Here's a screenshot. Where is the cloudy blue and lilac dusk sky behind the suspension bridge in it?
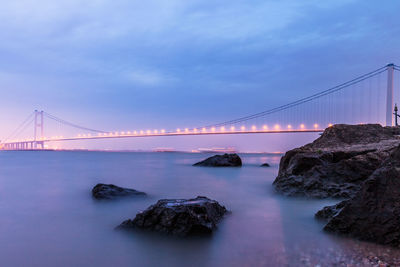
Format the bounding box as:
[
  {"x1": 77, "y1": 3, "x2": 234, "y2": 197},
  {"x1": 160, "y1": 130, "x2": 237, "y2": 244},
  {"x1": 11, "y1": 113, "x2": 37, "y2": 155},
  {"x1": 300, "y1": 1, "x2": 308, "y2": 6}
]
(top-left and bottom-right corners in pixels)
[{"x1": 0, "y1": 0, "x2": 400, "y2": 151}]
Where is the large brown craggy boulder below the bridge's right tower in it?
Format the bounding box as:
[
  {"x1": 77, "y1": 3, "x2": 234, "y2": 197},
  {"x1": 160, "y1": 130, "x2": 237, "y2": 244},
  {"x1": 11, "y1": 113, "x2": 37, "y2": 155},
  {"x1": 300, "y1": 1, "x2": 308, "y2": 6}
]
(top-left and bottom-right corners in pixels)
[{"x1": 273, "y1": 124, "x2": 400, "y2": 198}]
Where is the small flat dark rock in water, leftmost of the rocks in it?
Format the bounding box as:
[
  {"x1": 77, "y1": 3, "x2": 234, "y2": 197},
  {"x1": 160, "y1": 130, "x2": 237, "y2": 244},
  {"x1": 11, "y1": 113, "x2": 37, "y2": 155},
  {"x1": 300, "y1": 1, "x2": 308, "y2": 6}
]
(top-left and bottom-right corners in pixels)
[{"x1": 92, "y1": 184, "x2": 146, "y2": 199}]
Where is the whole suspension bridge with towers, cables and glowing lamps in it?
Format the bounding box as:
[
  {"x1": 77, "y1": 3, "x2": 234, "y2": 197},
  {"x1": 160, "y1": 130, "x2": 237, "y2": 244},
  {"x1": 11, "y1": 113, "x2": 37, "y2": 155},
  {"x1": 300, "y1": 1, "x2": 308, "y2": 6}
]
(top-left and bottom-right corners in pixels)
[{"x1": 0, "y1": 64, "x2": 400, "y2": 150}]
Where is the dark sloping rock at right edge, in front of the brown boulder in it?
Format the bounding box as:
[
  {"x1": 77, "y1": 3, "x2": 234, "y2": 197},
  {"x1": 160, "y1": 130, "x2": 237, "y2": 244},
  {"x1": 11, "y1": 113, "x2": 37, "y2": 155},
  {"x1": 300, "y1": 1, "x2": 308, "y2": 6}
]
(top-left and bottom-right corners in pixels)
[{"x1": 324, "y1": 147, "x2": 400, "y2": 247}]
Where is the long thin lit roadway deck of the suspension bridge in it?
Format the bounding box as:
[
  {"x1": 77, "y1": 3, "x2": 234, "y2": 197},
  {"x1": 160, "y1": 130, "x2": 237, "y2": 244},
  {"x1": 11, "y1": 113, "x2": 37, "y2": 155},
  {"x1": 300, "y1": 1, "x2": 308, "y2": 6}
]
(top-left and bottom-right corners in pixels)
[{"x1": 0, "y1": 129, "x2": 324, "y2": 150}]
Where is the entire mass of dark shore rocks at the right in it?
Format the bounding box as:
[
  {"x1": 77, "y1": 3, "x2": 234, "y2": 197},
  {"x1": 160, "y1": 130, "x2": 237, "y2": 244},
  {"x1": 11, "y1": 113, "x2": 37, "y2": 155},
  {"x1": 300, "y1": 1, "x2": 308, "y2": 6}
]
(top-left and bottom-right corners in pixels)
[{"x1": 273, "y1": 124, "x2": 400, "y2": 247}]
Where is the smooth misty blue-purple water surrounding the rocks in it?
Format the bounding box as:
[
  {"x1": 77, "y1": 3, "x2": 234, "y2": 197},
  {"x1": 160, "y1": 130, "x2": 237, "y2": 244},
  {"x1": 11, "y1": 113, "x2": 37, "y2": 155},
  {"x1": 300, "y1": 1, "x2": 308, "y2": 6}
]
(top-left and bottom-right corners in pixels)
[{"x1": 0, "y1": 151, "x2": 398, "y2": 266}]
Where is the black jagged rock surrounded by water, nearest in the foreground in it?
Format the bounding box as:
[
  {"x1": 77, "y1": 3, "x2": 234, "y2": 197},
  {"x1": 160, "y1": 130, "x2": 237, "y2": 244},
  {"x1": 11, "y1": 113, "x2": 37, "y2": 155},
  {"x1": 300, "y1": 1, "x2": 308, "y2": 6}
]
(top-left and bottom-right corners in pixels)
[{"x1": 117, "y1": 196, "x2": 227, "y2": 236}]
